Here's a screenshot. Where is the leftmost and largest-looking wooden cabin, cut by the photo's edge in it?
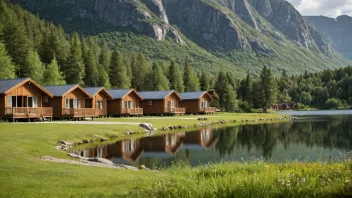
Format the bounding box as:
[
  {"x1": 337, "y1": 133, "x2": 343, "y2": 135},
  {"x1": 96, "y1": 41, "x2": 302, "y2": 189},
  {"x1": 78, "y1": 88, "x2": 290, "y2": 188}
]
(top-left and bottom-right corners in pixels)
[{"x1": 0, "y1": 78, "x2": 53, "y2": 121}]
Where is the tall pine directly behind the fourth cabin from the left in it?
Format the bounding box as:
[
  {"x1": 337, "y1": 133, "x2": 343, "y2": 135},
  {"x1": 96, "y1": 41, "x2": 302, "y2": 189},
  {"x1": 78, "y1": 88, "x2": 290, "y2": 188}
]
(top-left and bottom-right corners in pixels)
[{"x1": 110, "y1": 47, "x2": 130, "y2": 88}]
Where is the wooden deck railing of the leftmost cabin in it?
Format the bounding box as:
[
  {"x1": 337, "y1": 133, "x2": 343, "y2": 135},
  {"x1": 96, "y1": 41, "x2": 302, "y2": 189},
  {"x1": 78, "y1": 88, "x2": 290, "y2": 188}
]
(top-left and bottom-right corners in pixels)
[{"x1": 5, "y1": 107, "x2": 53, "y2": 117}]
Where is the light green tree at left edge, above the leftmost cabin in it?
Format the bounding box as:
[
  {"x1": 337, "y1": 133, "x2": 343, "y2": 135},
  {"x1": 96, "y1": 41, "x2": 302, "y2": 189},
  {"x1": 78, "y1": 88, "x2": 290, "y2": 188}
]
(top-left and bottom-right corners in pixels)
[{"x1": 0, "y1": 42, "x2": 16, "y2": 79}]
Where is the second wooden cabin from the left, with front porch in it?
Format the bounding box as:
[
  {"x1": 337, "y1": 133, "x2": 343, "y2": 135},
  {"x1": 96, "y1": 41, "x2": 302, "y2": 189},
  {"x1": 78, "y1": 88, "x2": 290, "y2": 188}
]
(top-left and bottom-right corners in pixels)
[{"x1": 44, "y1": 85, "x2": 96, "y2": 119}]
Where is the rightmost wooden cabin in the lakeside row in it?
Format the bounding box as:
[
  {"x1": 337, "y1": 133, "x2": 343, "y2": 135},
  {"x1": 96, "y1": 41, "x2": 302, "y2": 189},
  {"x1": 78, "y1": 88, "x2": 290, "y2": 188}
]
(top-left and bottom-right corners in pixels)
[{"x1": 180, "y1": 91, "x2": 216, "y2": 114}]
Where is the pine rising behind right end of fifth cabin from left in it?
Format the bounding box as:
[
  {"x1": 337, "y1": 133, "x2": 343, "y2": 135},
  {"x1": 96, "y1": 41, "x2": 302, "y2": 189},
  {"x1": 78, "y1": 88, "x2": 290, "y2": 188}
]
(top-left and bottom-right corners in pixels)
[{"x1": 168, "y1": 61, "x2": 184, "y2": 93}]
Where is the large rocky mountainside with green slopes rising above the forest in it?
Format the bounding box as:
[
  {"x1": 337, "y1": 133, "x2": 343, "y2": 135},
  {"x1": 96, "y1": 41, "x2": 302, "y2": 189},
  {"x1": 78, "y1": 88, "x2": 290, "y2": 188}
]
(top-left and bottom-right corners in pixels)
[{"x1": 11, "y1": 0, "x2": 351, "y2": 76}]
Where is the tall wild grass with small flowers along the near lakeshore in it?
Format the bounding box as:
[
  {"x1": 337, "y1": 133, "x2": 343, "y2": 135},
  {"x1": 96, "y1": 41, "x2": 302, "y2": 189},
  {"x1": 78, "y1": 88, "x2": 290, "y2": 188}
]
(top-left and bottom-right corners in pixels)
[{"x1": 131, "y1": 162, "x2": 352, "y2": 198}]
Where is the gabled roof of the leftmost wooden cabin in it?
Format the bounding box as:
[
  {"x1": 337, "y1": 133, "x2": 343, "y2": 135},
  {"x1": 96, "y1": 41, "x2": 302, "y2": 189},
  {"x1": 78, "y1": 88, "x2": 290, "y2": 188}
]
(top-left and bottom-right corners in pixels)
[{"x1": 0, "y1": 78, "x2": 53, "y2": 97}]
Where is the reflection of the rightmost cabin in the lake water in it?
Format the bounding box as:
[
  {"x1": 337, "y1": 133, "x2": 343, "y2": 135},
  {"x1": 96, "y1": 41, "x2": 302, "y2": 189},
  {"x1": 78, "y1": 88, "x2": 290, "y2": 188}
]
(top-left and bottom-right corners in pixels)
[{"x1": 182, "y1": 128, "x2": 219, "y2": 150}]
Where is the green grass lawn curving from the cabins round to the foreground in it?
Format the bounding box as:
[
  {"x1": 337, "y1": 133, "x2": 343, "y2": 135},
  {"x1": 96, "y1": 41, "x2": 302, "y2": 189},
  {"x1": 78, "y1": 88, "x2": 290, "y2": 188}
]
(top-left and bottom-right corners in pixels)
[{"x1": 0, "y1": 114, "x2": 352, "y2": 197}]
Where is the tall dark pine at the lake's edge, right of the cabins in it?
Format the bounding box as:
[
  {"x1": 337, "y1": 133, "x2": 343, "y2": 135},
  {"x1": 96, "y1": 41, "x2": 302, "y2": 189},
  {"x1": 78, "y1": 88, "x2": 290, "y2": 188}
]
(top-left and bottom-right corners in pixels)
[{"x1": 260, "y1": 66, "x2": 276, "y2": 113}]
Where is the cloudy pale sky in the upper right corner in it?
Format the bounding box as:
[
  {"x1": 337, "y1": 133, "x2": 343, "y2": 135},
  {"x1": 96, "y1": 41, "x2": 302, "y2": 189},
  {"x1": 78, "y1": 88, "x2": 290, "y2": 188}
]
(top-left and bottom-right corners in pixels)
[{"x1": 287, "y1": 0, "x2": 352, "y2": 18}]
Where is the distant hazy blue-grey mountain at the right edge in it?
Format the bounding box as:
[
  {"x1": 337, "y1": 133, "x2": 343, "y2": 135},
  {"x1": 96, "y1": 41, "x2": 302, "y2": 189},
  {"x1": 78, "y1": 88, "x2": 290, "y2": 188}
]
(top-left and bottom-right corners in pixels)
[{"x1": 304, "y1": 15, "x2": 352, "y2": 59}]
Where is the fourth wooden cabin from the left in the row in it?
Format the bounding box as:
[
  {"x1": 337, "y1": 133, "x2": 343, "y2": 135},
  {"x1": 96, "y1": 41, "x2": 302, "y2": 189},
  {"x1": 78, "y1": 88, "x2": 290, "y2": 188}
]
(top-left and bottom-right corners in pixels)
[{"x1": 108, "y1": 89, "x2": 143, "y2": 116}]
